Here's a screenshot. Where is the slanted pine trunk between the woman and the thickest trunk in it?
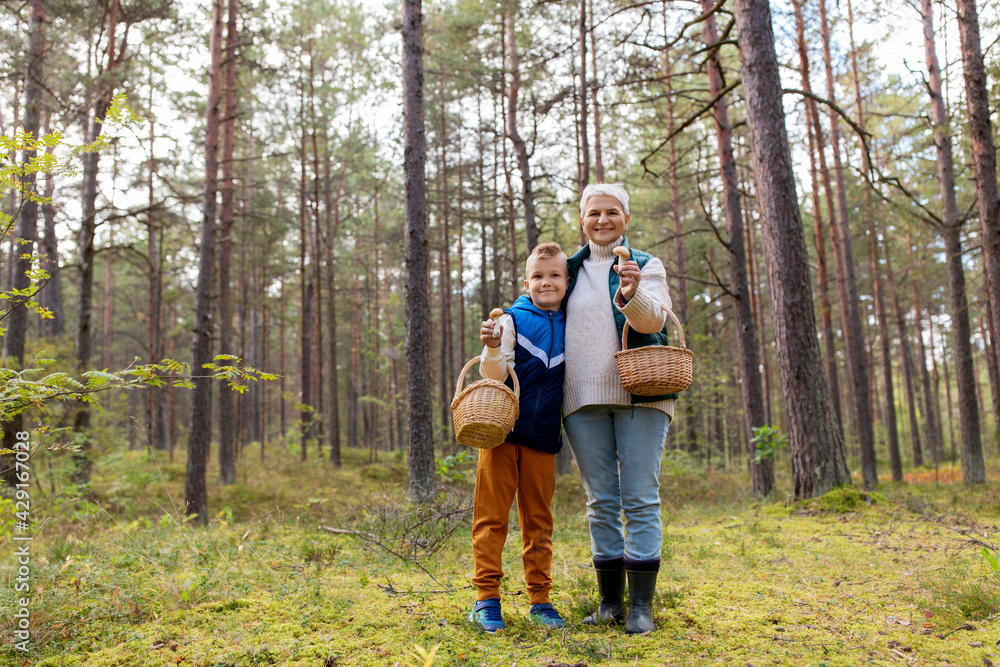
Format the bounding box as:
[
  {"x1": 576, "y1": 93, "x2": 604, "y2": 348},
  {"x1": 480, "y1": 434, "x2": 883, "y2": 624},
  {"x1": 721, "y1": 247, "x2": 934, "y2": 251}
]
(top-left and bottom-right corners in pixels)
[{"x1": 701, "y1": 0, "x2": 774, "y2": 497}]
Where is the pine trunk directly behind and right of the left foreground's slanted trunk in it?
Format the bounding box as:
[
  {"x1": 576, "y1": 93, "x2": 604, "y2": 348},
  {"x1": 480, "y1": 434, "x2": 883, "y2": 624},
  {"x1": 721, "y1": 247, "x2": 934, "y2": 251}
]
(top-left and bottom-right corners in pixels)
[{"x1": 219, "y1": 0, "x2": 237, "y2": 486}]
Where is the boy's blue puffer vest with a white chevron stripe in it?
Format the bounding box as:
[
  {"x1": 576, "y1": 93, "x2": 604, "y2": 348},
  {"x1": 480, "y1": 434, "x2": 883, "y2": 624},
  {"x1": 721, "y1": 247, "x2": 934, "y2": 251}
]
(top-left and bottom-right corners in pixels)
[{"x1": 504, "y1": 296, "x2": 566, "y2": 454}]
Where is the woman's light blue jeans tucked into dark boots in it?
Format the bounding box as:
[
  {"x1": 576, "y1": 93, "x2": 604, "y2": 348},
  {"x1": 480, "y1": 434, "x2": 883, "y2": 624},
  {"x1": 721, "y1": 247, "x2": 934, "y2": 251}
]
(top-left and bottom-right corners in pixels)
[{"x1": 563, "y1": 405, "x2": 669, "y2": 561}]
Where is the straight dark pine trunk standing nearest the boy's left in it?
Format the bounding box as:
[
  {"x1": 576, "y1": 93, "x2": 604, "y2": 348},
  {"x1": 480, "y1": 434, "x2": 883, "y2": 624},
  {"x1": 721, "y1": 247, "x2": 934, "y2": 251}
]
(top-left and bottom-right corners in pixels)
[{"x1": 403, "y1": 0, "x2": 436, "y2": 501}]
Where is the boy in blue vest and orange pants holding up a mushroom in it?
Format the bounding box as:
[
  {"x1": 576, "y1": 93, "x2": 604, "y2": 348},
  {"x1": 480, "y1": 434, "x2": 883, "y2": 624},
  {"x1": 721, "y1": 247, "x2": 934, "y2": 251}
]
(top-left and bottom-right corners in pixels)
[{"x1": 470, "y1": 243, "x2": 569, "y2": 632}]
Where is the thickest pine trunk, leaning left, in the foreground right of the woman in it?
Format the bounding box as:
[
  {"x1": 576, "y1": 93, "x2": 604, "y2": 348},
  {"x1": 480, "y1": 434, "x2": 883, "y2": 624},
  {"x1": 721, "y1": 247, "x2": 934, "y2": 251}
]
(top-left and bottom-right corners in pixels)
[{"x1": 734, "y1": 0, "x2": 851, "y2": 498}]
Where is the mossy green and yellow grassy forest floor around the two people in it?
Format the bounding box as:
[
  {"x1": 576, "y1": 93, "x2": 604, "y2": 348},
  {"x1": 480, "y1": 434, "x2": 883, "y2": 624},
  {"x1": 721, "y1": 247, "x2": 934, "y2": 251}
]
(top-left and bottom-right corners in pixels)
[{"x1": 0, "y1": 449, "x2": 1000, "y2": 667}]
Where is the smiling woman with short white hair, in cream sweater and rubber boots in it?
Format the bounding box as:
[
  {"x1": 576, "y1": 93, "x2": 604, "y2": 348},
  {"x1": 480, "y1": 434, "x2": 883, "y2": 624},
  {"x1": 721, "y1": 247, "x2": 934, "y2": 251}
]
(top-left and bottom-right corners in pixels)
[{"x1": 563, "y1": 183, "x2": 676, "y2": 634}]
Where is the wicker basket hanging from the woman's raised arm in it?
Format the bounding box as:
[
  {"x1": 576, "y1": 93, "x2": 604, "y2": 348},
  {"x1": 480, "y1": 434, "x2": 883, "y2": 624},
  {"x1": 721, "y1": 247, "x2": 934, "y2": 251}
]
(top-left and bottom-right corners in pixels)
[{"x1": 615, "y1": 304, "x2": 694, "y2": 396}]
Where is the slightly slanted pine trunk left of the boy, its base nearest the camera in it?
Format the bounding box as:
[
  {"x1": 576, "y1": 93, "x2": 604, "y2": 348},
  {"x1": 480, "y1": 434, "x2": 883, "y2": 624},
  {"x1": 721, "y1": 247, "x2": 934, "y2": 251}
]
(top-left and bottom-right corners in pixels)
[{"x1": 184, "y1": 0, "x2": 224, "y2": 525}]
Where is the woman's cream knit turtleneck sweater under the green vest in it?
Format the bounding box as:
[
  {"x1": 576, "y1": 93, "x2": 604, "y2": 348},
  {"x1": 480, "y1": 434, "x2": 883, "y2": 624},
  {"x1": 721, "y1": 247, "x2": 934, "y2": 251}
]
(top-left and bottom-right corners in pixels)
[{"x1": 563, "y1": 238, "x2": 674, "y2": 421}]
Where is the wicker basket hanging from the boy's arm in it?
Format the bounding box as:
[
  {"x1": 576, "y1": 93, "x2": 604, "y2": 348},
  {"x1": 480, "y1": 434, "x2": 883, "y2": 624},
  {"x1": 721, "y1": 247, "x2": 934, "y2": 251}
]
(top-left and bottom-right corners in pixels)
[{"x1": 451, "y1": 357, "x2": 521, "y2": 449}]
